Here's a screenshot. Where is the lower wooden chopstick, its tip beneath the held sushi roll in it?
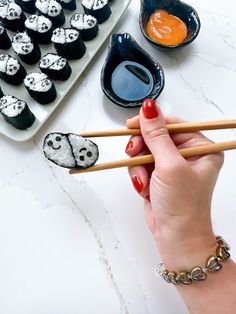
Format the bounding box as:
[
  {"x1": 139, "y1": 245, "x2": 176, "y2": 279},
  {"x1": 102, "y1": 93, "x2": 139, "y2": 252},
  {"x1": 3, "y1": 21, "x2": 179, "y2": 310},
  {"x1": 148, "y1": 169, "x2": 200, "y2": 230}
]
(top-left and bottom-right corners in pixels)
[{"x1": 69, "y1": 141, "x2": 236, "y2": 174}]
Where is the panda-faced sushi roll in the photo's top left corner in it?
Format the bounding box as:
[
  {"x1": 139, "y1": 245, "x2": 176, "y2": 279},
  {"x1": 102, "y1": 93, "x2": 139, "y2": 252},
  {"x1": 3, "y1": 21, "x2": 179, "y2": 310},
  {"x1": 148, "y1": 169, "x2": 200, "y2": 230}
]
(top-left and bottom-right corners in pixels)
[{"x1": 0, "y1": 0, "x2": 25, "y2": 32}]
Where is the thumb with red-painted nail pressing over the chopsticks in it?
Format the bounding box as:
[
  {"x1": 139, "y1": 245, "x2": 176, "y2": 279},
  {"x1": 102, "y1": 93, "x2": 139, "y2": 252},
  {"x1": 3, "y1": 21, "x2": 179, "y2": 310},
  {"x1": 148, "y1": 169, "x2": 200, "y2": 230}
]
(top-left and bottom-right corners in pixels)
[{"x1": 140, "y1": 99, "x2": 183, "y2": 165}]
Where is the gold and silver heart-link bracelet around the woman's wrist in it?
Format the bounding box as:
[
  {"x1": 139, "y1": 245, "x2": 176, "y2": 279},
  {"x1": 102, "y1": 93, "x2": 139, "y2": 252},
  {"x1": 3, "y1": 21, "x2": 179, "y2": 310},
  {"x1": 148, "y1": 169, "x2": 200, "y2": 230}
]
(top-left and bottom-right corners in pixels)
[{"x1": 156, "y1": 236, "x2": 230, "y2": 285}]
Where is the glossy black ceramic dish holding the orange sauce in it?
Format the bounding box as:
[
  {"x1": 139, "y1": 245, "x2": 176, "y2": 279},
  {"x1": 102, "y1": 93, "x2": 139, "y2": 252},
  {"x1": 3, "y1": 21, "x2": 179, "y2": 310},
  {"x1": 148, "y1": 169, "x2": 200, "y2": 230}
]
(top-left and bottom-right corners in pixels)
[{"x1": 139, "y1": 0, "x2": 201, "y2": 51}]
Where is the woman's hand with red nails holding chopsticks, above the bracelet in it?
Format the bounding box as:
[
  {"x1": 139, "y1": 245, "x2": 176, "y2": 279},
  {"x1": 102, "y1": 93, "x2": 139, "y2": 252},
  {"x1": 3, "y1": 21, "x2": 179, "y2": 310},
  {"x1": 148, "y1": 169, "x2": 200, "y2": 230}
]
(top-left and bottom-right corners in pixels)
[{"x1": 126, "y1": 100, "x2": 223, "y2": 269}]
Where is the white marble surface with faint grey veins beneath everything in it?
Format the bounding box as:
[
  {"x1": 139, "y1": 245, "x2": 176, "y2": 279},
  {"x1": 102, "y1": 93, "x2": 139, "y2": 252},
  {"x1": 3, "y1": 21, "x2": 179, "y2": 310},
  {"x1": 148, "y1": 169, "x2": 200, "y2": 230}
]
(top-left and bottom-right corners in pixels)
[{"x1": 0, "y1": 0, "x2": 236, "y2": 314}]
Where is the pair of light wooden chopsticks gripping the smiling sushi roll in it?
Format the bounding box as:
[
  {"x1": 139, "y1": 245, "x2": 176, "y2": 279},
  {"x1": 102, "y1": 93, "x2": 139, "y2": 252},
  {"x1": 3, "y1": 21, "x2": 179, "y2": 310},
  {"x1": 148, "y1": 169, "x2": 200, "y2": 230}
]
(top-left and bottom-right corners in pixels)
[{"x1": 69, "y1": 119, "x2": 236, "y2": 174}]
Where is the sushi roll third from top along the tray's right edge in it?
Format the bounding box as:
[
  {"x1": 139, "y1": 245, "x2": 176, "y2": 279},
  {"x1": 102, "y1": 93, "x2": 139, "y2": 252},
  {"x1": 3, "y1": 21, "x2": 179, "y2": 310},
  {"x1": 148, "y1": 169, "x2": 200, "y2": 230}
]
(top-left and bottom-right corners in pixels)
[{"x1": 52, "y1": 28, "x2": 86, "y2": 60}]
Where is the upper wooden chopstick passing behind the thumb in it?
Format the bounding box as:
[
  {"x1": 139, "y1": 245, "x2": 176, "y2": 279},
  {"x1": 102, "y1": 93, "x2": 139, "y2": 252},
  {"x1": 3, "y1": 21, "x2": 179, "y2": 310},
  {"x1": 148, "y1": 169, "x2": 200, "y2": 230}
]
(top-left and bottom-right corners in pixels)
[{"x1": 79, "y1": 119, "x2": 236, "y2": 137}]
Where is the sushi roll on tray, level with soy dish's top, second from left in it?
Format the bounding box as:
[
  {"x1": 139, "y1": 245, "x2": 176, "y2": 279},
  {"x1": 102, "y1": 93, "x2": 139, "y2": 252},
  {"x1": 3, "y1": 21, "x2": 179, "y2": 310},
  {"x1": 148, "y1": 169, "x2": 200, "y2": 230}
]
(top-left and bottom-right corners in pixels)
[{"x1": 12, "y1": 32, "x2": 41, "y2": 64}]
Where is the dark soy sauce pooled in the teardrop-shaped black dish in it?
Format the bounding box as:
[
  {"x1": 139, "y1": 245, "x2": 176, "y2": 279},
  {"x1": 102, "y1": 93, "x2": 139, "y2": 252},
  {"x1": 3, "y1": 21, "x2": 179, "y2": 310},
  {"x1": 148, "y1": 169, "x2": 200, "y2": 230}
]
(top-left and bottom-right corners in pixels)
[{"x1": 111, "y1": 61, "x2": 154, "y2": 101}]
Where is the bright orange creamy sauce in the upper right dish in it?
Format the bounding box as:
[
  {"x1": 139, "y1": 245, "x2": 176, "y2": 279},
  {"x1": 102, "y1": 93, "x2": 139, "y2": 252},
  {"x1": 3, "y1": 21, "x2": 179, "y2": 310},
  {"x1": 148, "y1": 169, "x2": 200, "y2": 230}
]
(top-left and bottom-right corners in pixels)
[{"x1": 146, "y1": 10, "x2": 187, "y2": 45}]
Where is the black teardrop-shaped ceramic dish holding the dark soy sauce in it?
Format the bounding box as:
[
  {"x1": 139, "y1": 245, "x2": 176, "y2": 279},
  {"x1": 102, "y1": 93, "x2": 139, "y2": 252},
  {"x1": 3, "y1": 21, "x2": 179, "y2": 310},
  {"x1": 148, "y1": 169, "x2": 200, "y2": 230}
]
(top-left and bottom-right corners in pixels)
[{"x1": 101, "y1": 33, "x2": 165, "y2": 108}]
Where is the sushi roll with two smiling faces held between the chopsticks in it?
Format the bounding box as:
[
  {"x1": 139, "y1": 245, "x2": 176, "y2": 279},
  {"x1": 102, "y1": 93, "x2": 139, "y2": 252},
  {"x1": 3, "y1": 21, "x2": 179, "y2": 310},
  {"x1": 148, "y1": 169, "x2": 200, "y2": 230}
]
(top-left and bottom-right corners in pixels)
[{"x1": 43, "y1": 133, "x2": 99, "y2": 168}]
